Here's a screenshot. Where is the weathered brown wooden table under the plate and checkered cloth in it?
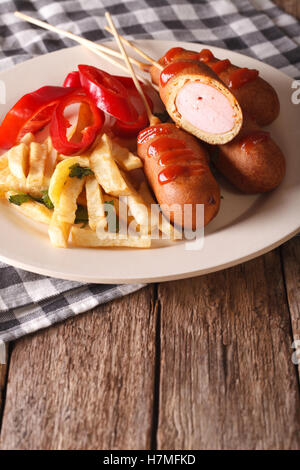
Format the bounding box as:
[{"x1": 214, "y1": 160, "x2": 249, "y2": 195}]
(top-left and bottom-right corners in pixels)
[{"x1": 0, "y1": 0, "x2": 300, "y2": 449}]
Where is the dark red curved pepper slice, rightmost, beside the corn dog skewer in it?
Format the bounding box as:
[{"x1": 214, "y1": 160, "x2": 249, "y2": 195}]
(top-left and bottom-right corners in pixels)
[{"x1": 112, "y1": 77, "x2": 153, "y2": 137}]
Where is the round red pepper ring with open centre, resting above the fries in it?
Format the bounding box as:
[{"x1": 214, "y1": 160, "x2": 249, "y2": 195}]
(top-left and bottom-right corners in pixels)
[{"x1": 50, "y1": 91, "x2": 104, "y2": 155}]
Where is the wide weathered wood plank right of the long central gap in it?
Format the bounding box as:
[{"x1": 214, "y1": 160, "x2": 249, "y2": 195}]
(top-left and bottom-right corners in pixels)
[{"x1": 158, "y1": 251, "x2": 300, "y2": 449}]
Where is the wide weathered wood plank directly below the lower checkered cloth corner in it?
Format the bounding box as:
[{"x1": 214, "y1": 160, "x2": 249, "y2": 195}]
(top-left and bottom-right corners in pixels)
[{"x1": 0, "y1": 287, "x2": 156, "y2": 449}]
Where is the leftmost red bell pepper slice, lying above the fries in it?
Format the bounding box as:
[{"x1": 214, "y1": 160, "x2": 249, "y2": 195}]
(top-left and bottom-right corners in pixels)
[{"x1": 0, "y1": 86, "x2": 73, "y2": 149}]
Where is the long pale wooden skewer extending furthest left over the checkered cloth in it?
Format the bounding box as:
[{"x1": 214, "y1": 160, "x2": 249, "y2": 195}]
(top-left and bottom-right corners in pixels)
[{"x1": 15, "y1": 11, "x2": 147, "y2": 71}]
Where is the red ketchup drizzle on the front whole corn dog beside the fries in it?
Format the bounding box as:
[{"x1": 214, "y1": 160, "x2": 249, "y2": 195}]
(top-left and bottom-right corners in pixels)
[{"x1": 147, "y1": 136, "x2": 205, "y2": 184}]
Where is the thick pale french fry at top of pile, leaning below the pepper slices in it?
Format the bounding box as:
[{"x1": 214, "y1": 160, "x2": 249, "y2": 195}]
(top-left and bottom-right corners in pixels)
[{"x1": 90, "y1": 134, "x2": 129, "y2": 196}]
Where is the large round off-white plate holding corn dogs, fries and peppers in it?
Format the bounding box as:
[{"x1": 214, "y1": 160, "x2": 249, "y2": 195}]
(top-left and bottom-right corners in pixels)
[{"x1": 0, "y1": 41, "x2": 300, "y2": 283}]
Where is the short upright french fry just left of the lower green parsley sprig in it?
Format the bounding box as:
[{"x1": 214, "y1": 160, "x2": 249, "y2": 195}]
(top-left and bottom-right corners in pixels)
[{"x1": 55, "y1": 177, "x2": 85, "y2": 224}]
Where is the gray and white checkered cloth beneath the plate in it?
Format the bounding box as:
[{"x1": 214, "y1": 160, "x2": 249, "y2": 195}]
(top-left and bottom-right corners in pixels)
[{"x1": 0, "y1": 0, "x2": 300, "y2": 342}]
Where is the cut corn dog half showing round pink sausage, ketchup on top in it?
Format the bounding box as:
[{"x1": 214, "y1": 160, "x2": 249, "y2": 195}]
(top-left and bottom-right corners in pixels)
[{"x1": 159, "y1": 60, "x2": 243, "y2": 144}]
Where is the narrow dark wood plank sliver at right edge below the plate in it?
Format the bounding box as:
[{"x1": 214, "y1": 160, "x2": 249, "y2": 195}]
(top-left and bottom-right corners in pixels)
[{"x1": 281, "y1": 237, "x2": 300, "y2": 376}]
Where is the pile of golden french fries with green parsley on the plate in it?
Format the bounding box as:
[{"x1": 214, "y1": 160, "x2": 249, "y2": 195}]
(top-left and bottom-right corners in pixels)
[{"x1": 0, "y1": 106, "x2": 181, "y2": 248}]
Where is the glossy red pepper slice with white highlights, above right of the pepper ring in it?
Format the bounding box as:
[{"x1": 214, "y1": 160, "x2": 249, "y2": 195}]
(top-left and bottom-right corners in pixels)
[{"x1": 78, "y1": 65, "x2": 138, "y2": 122}]
